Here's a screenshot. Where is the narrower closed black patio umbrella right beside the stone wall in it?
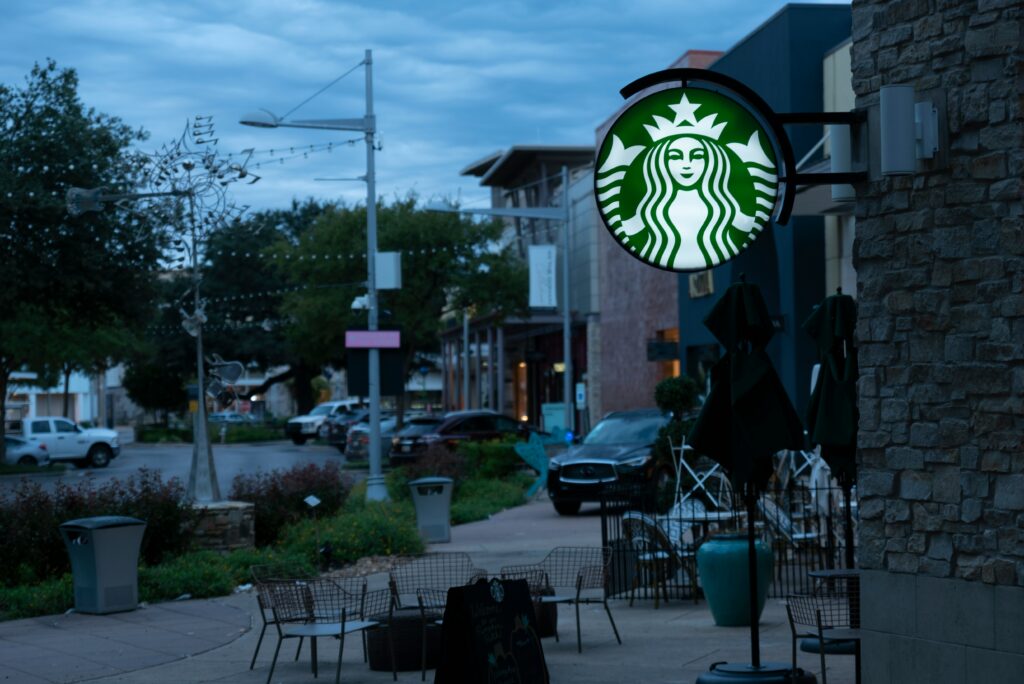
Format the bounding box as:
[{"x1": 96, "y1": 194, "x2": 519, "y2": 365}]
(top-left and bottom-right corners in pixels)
[{"x1": 804, "y1": 289, "x2": 860, "y2": 567}]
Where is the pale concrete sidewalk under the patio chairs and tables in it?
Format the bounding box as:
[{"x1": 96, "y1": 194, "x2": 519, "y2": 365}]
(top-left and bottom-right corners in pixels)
[{"x1": 0, "y1": 501, "x2": 853, "y2": 684}]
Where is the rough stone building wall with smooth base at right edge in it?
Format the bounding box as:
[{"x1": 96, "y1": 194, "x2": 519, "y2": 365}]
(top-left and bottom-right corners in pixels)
[{"x1": 852, "y1": 0, "x2": 1024, "y2": 684}]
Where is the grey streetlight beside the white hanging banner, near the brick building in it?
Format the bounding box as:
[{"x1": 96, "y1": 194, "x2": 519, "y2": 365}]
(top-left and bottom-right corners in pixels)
[{"x1": 426, "y1": 166, "x2": 575, "y2": 431}]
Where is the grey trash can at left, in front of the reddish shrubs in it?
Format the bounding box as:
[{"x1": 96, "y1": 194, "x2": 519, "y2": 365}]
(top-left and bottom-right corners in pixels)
[{"x1": 60, "y1": 515, "x2": 145, "y2": 613}]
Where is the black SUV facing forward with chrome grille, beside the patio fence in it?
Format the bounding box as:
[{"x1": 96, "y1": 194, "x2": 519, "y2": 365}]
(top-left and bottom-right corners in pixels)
[{"x1": 548, "y1": 409, "x2": 675, "y2": 515}]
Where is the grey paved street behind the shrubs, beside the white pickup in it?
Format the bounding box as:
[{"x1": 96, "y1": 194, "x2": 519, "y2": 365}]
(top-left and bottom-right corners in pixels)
[{"x1": 0, "y1": 440, "x2": 359, "y2": 496}]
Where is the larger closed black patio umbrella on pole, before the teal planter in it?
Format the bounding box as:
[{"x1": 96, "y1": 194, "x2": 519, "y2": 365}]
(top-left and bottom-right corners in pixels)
[{"x1": 689, "y1": 275, "x2": 804, "y2": 681}]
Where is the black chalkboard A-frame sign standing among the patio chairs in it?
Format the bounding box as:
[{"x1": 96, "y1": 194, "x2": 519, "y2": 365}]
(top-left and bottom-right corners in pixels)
[{"x1": 434, "y1": 580, "x2": 550, "y2": 684}]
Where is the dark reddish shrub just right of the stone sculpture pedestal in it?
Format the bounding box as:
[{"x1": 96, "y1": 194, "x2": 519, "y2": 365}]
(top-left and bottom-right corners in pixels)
[{"x1": 229, "y1": 463, "x2": 351, "y2": 546}]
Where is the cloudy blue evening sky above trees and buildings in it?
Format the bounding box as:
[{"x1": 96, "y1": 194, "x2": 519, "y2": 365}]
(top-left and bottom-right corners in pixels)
[{"x1": 0, "y1": 0, "x2": 847, "y2": 214}]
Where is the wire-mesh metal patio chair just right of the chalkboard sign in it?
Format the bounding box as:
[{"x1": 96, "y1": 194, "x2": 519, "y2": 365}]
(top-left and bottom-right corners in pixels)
[{"x1": 502, "y1": 546, "x2": 623, "y2": 653}]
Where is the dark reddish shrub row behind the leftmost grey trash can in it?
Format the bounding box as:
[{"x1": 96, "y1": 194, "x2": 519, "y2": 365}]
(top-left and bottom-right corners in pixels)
[{"x1": 0, "y1": 468, "x2": 198, "y2": 586}]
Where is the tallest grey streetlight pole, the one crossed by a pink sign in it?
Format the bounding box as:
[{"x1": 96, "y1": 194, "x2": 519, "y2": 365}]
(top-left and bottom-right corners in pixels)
[{"x1": 239, "y1": 50, "x2": 388, "y2": 501}]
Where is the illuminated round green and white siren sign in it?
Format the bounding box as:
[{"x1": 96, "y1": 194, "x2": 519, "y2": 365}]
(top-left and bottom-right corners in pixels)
[{"x1": 594, "y1": 88, "x2": 778, "y2": 271}]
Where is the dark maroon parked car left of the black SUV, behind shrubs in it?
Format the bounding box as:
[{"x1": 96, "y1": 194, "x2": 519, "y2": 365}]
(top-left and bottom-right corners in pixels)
[{"x1": 390, "y1": 411, "x2": 532, "y2": 463}]
